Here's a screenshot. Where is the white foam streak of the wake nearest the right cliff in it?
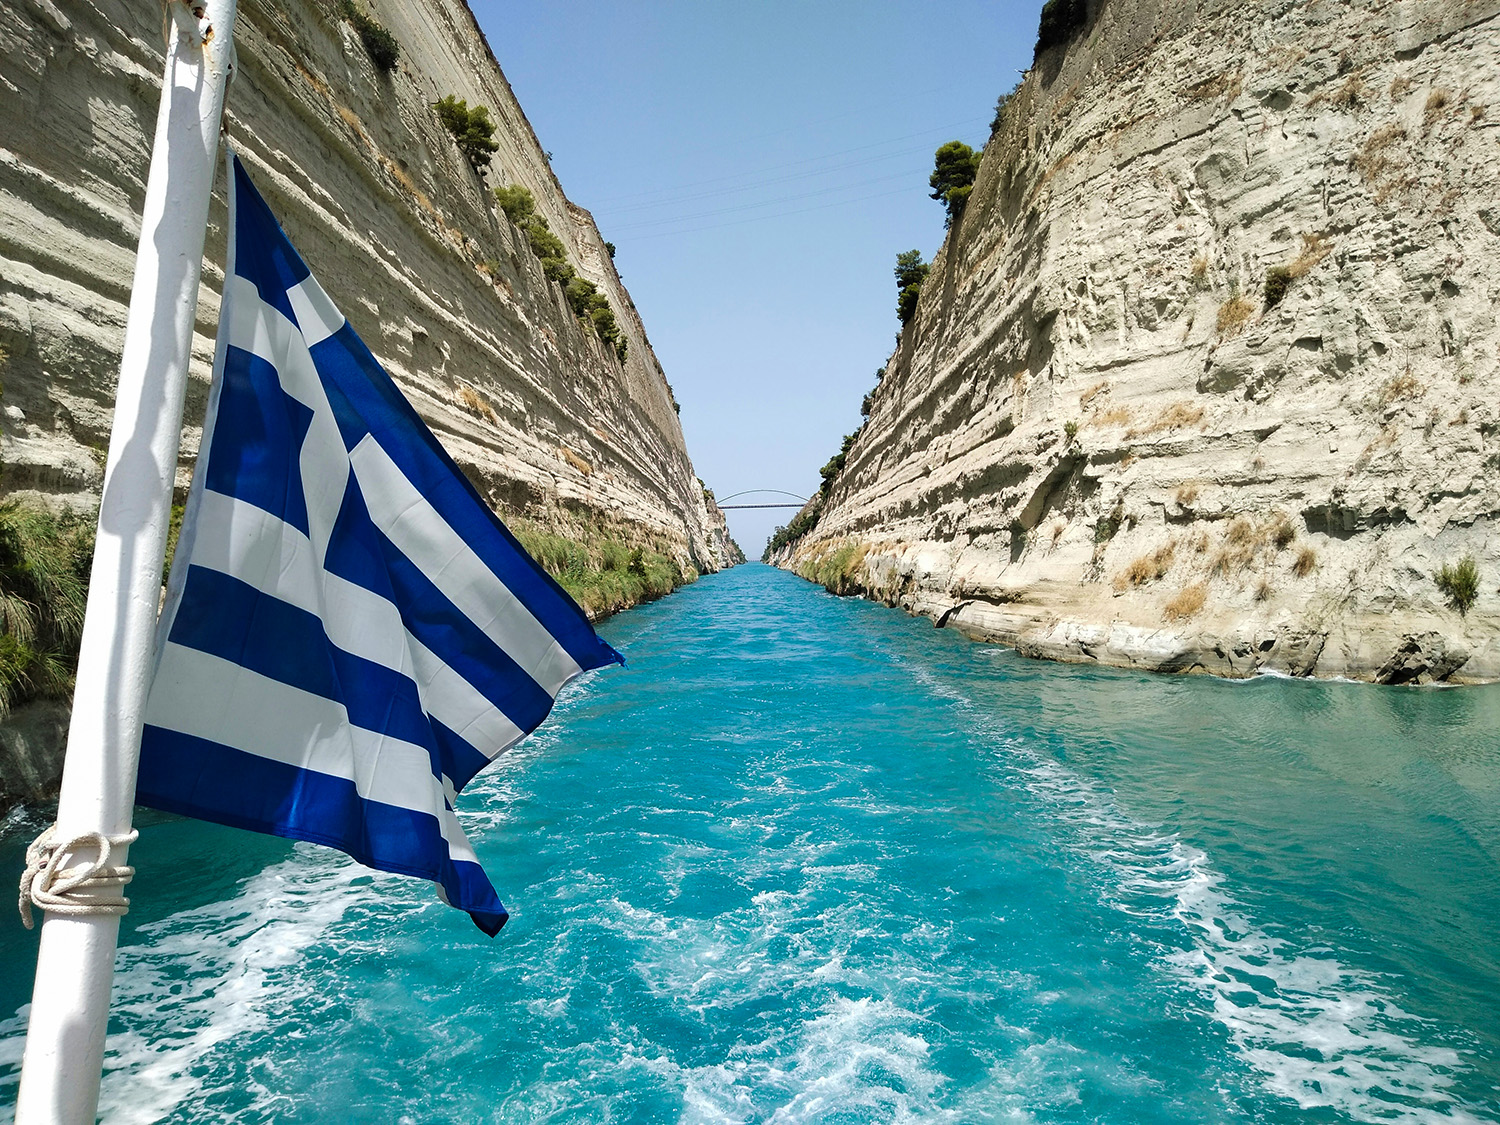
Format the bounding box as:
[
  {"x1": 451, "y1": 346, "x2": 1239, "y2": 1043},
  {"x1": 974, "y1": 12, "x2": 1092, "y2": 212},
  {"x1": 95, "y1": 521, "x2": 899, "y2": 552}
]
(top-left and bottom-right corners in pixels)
[{"x1": 909, "y1": 666, "x2": 1490, "y2": 1125}]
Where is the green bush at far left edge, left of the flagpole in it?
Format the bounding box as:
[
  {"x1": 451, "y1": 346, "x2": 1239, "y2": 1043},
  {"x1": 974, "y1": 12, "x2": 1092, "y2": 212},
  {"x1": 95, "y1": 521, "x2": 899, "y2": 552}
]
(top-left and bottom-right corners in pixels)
[{"x1": 0, "y1": 500, "x2": 95, "y2": 716}]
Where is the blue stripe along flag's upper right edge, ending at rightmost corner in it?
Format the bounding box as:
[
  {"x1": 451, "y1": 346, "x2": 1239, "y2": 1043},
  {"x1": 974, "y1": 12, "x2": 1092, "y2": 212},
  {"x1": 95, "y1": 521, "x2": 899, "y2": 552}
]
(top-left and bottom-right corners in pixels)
[{"x1": 312, "y1": 324, "x2": 624, "y2": 671}]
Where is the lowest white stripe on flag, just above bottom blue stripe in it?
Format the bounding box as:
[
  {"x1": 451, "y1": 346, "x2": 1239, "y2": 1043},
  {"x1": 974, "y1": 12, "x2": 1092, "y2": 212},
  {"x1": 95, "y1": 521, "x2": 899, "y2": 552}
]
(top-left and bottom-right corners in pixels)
[{"x1": 146, "y1": 642, "x2": 476, "y2": 863}]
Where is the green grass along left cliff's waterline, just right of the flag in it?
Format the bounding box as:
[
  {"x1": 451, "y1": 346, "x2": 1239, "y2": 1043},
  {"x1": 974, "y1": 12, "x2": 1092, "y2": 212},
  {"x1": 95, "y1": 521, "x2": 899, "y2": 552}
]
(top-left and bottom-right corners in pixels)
[{"x1": 506, "y1": 518, "x2": 698, "y2": 620}]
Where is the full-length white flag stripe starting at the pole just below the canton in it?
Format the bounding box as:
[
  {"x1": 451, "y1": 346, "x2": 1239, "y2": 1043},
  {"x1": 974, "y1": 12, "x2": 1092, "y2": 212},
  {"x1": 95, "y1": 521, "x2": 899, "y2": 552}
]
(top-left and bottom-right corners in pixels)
[{"x1": 192, "y1": 491, "x2": 524, "y2": 758}]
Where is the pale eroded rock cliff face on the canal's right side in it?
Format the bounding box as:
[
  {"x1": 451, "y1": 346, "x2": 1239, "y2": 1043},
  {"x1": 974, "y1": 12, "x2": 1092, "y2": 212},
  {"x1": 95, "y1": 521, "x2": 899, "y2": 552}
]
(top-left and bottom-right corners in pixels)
[{"x1": 777, "y1": 0, "x2": 1500, "y2": 680}]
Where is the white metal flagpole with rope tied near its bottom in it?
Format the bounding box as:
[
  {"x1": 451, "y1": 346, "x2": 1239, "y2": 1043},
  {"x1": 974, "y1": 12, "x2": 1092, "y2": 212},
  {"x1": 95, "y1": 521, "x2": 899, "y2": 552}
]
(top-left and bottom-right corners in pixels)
[{"x1": 15, "y1": 0, "x2": 236, "y2": 1125}]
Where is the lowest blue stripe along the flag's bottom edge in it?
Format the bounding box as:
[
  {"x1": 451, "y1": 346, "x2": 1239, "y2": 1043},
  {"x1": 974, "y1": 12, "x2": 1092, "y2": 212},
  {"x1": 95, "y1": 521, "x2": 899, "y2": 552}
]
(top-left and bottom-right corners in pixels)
[{"x1": 137, "y1": 726, "x2": 509, "y2": 936}]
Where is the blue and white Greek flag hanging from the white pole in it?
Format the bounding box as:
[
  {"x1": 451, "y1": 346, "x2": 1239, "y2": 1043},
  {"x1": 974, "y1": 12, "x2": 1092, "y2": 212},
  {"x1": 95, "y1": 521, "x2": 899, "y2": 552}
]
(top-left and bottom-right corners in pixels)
[{"x1": 137, "y1": 155, "x2": 620, "y2": 935}]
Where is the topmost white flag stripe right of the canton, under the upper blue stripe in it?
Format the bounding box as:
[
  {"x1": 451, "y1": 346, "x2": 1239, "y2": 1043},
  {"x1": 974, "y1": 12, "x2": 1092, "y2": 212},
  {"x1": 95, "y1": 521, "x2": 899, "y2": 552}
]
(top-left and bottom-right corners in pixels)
[{"x1": 350, "y1": 434, "x2": 582, "y2": 696}]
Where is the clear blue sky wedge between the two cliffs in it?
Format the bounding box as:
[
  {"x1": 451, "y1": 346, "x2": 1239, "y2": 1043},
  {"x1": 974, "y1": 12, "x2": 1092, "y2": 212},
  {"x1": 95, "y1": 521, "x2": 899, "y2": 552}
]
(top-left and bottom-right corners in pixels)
[{"x1": 473, "y1": 0, "x2": 1041, "y2": 557}]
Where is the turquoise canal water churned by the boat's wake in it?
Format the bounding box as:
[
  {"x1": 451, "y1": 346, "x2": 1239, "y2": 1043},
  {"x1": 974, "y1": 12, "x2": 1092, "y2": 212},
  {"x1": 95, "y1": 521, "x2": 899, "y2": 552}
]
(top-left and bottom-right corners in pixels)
[{"x1": 0, "y1": 566, "x2": 1500, "y2": 1124}]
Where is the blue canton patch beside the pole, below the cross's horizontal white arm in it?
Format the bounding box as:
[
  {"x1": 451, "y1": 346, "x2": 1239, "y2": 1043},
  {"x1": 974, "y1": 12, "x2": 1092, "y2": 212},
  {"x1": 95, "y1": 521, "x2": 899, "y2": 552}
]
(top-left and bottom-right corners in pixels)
[{"x1": 204, "y1": 347, "x2": 312, "y2": 536}]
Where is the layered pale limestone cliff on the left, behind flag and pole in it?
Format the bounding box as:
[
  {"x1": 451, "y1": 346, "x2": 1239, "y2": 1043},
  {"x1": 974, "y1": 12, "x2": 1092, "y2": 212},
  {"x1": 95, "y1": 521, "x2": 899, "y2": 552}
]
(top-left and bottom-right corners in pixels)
[{"x1": 0, "y1": 0, "x2": 731, "y2": 810}]
